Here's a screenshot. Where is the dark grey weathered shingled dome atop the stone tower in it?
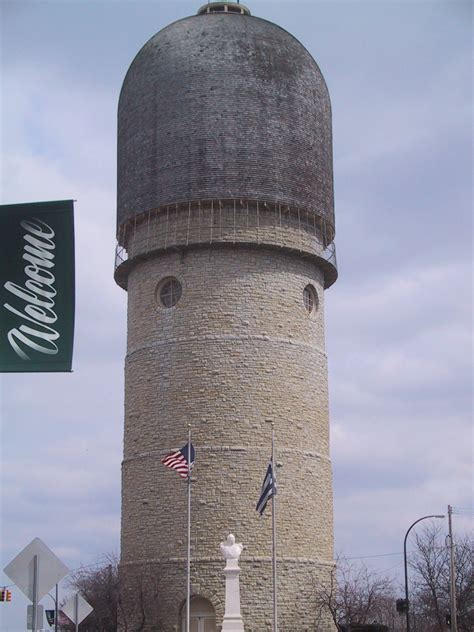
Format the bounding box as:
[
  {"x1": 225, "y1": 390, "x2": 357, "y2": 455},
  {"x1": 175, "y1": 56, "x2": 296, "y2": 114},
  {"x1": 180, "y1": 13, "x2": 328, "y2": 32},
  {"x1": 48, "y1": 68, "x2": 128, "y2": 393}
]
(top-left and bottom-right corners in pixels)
[{"x1": 118, "y1": 7, "x2": 334, "y2": 233}]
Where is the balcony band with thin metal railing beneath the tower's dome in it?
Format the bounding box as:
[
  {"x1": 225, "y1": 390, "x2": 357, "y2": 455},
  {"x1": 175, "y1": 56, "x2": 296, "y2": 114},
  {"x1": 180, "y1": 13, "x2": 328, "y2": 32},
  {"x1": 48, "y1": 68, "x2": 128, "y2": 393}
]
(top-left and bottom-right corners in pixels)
[{"x1": 115, "y1": 199, "x2": 337, "y2": 276}]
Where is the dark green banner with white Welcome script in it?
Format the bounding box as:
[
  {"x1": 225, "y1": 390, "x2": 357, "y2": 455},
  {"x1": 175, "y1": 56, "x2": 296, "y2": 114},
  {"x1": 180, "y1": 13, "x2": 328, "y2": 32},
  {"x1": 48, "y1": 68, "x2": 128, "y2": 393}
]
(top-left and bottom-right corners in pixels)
[{"x1": 0, "y1": 200, "x2": 75, "y2": 372}]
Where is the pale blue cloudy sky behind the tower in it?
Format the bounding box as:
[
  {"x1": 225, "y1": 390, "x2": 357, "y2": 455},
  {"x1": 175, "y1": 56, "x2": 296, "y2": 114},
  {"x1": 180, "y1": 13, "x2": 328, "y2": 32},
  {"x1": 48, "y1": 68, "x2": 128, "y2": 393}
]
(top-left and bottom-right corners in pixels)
[{"x1": 0, "y1": 0, "x2": 473, "y2": 632}]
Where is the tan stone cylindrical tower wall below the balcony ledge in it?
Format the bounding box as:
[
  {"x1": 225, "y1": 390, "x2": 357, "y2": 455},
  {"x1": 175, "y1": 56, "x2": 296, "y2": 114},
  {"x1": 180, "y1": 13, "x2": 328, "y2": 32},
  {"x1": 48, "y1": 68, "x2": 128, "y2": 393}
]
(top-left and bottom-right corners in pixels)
[{"x1": 121, "y1": 244, "x2": 333, "y2": 632}]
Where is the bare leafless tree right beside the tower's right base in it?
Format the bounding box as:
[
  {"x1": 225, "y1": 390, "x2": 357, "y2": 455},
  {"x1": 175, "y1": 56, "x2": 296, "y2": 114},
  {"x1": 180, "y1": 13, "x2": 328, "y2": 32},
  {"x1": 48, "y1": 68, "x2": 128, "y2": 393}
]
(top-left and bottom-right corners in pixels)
[{"x1": 316, "y1": 557, "x2": 395, "y2": 630}]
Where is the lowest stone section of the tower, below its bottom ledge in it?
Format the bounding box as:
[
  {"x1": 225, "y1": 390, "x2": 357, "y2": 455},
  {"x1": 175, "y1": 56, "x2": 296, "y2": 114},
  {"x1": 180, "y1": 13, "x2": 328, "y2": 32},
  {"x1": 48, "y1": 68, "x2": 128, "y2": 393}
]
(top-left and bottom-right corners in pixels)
[{"x1": 118, "y1": 557, "x2": 335, "y2": 632}]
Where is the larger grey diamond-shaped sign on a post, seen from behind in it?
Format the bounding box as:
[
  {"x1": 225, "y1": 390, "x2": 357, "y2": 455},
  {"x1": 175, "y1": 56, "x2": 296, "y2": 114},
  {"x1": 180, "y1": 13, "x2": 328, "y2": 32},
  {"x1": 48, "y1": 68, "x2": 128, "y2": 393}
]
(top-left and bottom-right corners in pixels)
[{"x1": 3, "y1": 538, "x2": 69, "y2": 632}]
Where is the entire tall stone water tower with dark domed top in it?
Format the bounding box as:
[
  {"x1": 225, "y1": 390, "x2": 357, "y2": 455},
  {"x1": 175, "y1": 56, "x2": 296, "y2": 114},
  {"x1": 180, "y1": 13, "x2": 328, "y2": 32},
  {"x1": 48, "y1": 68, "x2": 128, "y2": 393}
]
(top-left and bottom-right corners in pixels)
[{"x1": 115, "y1": 2, "x2": 337, "y2": 632}]
